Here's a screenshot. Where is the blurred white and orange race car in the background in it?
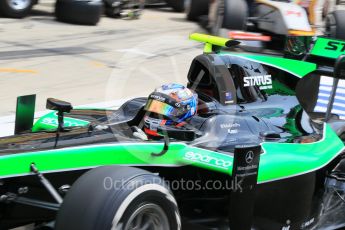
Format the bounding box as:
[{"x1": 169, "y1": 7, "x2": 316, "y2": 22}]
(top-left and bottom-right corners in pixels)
[{"x1": 187, "y1": 0, "x2": 345, "y2": 51}]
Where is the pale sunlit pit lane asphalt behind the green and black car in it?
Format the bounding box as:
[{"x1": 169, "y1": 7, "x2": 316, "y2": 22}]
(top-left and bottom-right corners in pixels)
[{"x1": 0, "y1": 2, "x2": 202, "y2": 120}]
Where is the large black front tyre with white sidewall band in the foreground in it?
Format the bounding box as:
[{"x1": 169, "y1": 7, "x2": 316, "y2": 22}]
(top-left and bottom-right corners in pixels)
[{"x1": 55, "y1": 166, "x2": 181, "y2": 230}]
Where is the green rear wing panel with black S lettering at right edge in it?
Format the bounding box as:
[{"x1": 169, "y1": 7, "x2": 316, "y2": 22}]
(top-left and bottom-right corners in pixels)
[{"x1": 311, "y1": 37, "x2": 345, "y2": 59}]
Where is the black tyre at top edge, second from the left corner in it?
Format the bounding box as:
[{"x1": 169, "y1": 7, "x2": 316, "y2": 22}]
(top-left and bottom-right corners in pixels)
[{"x1": 55, "y1": 0, "x2": 103, "y2": 25}]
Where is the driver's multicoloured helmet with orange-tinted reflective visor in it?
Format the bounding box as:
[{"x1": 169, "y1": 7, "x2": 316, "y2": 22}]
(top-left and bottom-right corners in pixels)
[{"x1": 144, "y1": 83, "x2": 198, "y2": 136}]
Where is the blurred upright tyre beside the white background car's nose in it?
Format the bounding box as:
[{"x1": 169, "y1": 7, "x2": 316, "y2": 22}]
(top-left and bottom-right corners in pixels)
[{"x1": 218, "y1": 0, "x2": 248, "y2": 30}]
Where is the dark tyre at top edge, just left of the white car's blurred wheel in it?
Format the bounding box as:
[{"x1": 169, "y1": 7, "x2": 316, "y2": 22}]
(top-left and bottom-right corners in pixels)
[{"x1": 185, "y1": 0, "x2": 209, "y2": 21}]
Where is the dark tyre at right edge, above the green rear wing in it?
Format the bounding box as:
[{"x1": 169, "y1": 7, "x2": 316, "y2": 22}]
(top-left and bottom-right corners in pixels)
[{"x1": 326, "y1": 10, "x2": 345, "y2": 40}]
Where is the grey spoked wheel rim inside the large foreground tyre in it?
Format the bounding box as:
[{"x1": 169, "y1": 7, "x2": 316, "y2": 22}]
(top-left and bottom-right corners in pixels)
[{"x1": 124, "y1": 203, "x2": 170, "y2": 230}]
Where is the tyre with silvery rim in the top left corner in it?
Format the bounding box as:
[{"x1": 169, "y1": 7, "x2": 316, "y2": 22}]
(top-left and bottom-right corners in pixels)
[{"x1": 0, "y1": 0, "x2": 34, "y2": 18}]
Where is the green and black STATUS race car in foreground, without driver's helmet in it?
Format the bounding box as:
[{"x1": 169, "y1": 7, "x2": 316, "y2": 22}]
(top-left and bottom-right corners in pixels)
[{"x1": 0, "y1": 34, "x2": 345, "y2": 230}]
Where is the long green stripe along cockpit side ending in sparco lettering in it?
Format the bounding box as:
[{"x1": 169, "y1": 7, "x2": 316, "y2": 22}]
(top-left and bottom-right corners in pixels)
[{"x1": 0, "y1": 142, "x2": 232, "y2": 178}]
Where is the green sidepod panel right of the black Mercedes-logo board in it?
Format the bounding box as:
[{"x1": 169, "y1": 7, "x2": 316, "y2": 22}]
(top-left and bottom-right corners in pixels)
[{"x1": 259, "y1": 125, "x2": 344, "y2": 182}]
